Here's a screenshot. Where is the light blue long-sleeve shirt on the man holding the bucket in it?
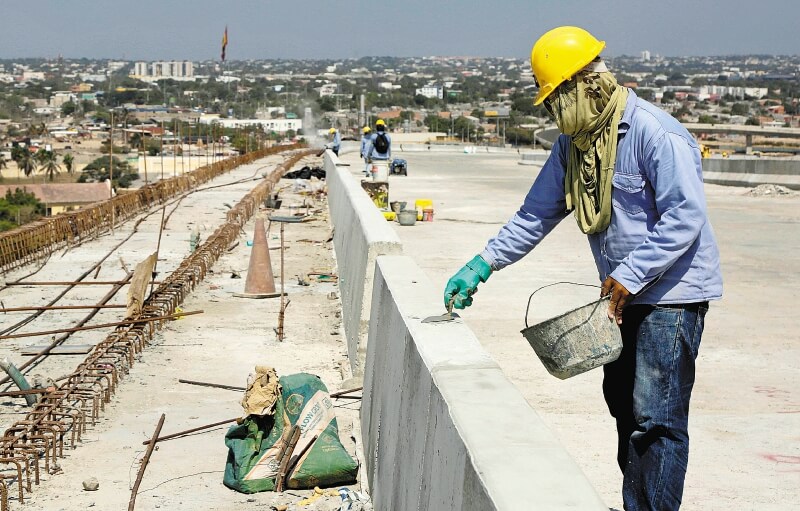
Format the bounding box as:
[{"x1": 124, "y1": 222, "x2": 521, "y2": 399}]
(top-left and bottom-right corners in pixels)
[{"x1": 481, "y1": 91, "x2": 722, "y2": 304}]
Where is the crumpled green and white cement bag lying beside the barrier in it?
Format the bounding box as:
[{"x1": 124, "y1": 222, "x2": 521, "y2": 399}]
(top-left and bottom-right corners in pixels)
[{"x1": 223, "y1": 373, "x2": 358, "y2": 493}]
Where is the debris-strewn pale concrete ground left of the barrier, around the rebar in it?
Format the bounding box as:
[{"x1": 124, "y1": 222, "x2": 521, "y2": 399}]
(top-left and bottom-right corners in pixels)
[{"x1": 0, "y1": 156, "x2": 360, "y2": 511}]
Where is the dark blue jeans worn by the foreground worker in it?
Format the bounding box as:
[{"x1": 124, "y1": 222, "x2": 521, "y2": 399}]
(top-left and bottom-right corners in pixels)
[{"x1": 603, "y1": 302, "x2": 708, "y2": 511}]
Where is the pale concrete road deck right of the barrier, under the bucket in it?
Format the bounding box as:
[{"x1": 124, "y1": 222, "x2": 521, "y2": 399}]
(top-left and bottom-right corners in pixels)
[{"x1": 343, "y1": 152, "x2": 800, "y2": 511}]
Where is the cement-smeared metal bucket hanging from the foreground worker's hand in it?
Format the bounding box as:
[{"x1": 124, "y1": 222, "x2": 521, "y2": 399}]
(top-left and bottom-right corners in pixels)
[{"x1": 522, "y1": 283, "x2": 622, "y2": 380}]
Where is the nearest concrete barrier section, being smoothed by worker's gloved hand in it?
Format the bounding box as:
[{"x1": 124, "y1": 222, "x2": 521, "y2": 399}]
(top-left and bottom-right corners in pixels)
[{"x1": 361, "y1": 256, "x2": 608, "y2": 511}]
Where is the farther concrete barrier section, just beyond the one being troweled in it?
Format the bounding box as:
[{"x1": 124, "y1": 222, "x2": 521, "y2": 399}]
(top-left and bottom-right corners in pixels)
[{"x1": 325, "y1": 151, "x2": 403, "y2": 375}]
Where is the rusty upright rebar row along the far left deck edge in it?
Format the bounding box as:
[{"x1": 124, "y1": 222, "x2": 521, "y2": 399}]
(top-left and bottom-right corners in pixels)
[{"x1": 0, "y1": 145, "x2": 300, "y2": 271}]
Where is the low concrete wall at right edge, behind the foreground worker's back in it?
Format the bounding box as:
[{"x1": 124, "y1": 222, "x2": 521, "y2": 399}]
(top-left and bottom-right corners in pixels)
[{"x1": 703, "y1": 158, "x2": 800, "y2": 190}]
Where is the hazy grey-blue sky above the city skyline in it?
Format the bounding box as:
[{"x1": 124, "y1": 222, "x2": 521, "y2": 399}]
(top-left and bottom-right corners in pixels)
[{"x1": 0, "y1": 0, "x2": 800, "y2": 60}]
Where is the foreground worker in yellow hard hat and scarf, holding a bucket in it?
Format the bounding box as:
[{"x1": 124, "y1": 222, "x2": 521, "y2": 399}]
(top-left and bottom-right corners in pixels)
[{"x1": 444, "y1": 27, "x2": 722, "y2": 511}]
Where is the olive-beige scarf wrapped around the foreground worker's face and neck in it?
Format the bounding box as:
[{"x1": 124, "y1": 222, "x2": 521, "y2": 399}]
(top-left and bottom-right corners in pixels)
[{"x1": 550, "y1": 61, "x2": 628, "y2": 234}]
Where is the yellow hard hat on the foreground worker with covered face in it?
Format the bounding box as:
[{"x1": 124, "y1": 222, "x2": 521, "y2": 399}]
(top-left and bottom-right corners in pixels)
[{"x1": 531, "y1": 27, "x2": 606, "y2": 105}]
